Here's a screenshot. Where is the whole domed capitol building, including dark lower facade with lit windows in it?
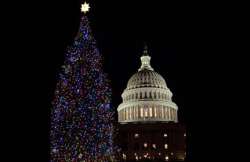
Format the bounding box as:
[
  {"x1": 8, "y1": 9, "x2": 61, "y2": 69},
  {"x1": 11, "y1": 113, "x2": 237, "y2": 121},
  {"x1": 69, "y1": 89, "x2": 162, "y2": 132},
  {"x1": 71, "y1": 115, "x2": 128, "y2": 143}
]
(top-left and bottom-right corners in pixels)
[{"x1": 117, "y1": 47, "x2": 186, "y2": 161}]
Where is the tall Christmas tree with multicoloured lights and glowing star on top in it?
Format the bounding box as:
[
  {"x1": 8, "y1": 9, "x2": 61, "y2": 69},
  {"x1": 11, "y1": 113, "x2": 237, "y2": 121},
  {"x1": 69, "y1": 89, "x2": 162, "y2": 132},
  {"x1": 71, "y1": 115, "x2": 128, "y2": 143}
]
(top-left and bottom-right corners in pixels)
[{"x1": 50, "y1": 3, "x2": 115, "y2": 162}]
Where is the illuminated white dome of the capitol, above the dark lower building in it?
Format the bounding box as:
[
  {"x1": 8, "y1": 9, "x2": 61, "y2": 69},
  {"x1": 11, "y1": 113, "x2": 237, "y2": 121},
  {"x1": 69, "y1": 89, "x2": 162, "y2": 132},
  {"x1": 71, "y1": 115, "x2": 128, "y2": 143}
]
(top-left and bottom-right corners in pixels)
[{"x1": 117, "y1": 47, "x2": 178, "y2": 123}]
